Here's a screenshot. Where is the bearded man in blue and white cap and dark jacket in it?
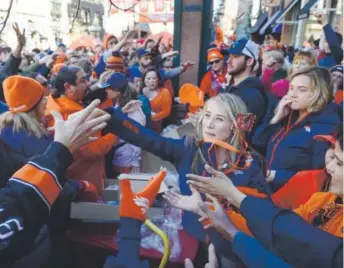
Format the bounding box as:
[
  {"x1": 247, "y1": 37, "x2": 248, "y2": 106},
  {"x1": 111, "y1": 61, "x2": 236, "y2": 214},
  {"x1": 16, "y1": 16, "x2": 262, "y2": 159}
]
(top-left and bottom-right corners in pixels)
[{"x1": 226, "y1": 38, "x2": 268, "y2": 130}]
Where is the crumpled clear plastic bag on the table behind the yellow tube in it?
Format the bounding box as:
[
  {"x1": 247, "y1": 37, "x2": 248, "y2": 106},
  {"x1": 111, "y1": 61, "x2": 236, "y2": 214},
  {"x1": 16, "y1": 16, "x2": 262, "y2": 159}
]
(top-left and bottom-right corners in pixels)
[{"x1": 141, "y1": 203, "x2": 182, "y2": 260}]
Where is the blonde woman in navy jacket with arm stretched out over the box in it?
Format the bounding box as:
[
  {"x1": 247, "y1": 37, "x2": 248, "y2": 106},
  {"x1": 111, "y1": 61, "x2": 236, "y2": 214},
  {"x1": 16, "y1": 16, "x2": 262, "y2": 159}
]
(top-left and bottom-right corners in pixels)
[{"x1": 103, "y1": 93, "x2": 270, "y2": 241}]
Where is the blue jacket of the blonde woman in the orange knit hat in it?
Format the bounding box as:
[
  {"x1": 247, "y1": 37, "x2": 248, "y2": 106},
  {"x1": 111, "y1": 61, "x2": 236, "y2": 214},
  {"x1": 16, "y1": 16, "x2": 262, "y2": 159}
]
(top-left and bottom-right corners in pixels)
[{"x1": 0, "y1": 127, "x2": 53, "y2": 158}]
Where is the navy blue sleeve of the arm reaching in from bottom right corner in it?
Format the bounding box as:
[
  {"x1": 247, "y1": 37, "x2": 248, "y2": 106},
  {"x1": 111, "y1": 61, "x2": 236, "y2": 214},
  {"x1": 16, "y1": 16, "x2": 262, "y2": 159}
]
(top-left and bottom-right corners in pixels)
[{"x1": 239, "y1": 196, "x2": 343, "y2": 268}]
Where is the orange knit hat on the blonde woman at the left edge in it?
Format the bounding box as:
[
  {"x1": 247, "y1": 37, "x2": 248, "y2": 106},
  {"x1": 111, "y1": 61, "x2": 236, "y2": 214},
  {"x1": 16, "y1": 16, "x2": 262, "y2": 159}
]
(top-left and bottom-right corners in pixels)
[{"x1": 3, "y1": 75, "x2": 44, "y2": 113}]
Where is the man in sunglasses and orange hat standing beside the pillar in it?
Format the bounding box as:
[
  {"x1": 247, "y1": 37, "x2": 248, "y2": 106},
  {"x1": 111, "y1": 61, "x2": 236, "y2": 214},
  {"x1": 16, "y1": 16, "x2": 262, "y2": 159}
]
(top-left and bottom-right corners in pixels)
[{"x1": 200, "y1": 48, "x2": 227, "y2": 97}]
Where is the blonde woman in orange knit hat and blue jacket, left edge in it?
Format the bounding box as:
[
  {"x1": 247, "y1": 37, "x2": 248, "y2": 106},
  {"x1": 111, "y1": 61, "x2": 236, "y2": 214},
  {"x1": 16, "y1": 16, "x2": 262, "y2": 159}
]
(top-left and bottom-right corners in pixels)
[{"x1": 0, "y1": 75, "x2": 52, "y2": 158}]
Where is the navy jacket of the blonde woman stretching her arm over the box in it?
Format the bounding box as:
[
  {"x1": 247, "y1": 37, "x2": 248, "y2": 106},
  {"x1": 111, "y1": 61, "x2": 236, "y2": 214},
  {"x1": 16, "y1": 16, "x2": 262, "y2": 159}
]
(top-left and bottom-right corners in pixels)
[{"x1": 105, "y1": 109, "x2": 270, "y2": 241}]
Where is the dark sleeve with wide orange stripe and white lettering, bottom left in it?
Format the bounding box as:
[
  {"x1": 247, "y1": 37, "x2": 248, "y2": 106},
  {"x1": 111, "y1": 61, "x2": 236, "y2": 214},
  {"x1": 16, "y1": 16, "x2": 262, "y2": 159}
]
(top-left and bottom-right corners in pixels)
[{"x1": 0, "y1": 142, "x2": 72, "y2": 267}]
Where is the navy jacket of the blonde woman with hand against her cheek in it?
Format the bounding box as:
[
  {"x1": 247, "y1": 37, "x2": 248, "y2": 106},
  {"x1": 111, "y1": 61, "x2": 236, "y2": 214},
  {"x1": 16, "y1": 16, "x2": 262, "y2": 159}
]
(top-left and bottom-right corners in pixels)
[{"x1": 252, "y1": 103, "x2": 341, "y2": 192}]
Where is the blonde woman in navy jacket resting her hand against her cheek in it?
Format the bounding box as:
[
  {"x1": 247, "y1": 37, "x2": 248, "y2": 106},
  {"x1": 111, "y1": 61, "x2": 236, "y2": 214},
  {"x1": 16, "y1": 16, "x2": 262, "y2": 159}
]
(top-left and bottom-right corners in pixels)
[{"x1": 253, "y1": 67, "x2": 340, "y2": 192}]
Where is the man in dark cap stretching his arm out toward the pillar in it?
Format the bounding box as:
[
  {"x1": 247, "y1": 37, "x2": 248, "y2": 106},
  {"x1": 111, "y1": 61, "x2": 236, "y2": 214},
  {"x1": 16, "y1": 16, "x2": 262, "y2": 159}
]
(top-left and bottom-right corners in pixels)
[{"x1": 128, "y1": 48, "x2": 195, "y2": 86}]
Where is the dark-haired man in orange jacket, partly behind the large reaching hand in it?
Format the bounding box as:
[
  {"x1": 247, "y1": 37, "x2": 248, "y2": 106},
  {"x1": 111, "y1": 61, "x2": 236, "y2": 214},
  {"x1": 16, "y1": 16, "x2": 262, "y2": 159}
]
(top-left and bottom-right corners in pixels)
[{"x1": 46, "y1": 66, "x2": 117, "y2": 194}]
